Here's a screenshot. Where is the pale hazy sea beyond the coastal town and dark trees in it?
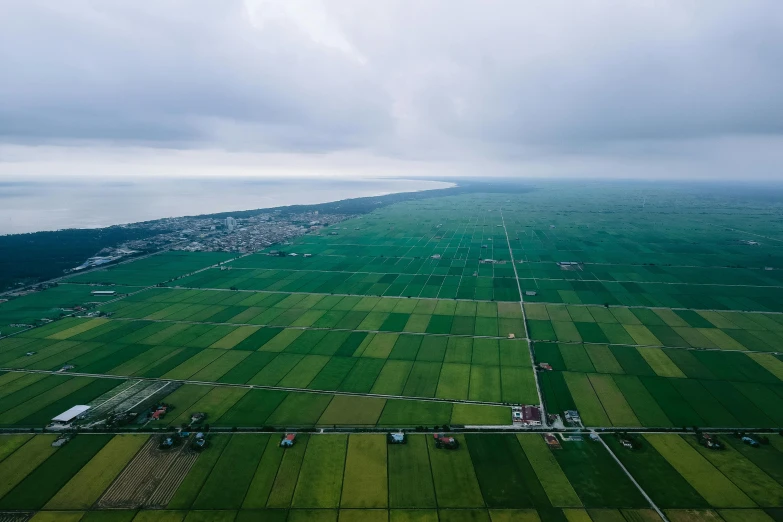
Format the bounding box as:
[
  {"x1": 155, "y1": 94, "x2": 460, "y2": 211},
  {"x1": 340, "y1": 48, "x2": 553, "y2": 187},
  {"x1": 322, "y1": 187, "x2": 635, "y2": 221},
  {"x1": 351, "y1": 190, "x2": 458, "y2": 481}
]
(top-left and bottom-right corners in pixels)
[{"x1": 0, "y1": 179, "x2": 452, "y2": 235}]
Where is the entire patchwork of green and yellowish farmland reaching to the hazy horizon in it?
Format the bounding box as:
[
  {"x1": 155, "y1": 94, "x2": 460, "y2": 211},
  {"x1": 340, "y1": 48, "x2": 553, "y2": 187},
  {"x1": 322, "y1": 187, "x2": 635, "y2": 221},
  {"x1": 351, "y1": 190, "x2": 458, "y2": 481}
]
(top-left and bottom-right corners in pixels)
[{"x1": 0, "y1": 183, "x2": 783, "y2": 522}]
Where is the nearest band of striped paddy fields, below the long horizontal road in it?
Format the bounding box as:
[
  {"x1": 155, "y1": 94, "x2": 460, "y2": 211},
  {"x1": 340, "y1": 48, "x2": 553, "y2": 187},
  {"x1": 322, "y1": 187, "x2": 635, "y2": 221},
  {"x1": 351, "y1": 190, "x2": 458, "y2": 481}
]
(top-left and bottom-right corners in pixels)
[{"x1": 0, "y1": 433, "x2": 783, "y2": 522}]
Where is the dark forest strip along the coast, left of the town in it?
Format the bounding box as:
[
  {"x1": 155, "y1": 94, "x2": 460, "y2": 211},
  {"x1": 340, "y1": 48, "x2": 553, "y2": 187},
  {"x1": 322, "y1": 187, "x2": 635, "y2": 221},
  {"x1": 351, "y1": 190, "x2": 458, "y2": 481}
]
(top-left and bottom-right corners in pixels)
[{"x1": 0, "y1": 226, "x2": 160, "y2": 290}]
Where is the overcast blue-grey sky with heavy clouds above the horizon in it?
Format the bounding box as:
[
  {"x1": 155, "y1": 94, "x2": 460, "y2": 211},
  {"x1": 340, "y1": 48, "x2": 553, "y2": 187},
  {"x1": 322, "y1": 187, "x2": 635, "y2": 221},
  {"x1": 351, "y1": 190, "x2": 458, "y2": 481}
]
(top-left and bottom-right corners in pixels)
[{"x1": 0, "y1": 0, "x2": 783, "y2": 181}]
